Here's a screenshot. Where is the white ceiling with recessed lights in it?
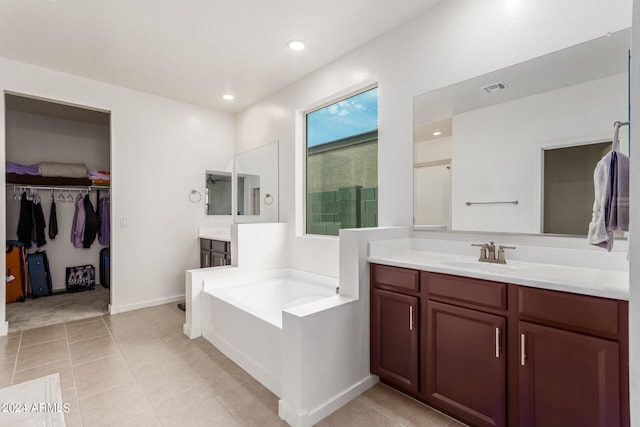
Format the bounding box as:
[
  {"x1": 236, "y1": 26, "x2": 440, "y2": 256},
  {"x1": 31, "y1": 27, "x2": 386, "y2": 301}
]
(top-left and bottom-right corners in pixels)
[{"x1": 0, "y1": 0, "x2": 441, "y2": 112}]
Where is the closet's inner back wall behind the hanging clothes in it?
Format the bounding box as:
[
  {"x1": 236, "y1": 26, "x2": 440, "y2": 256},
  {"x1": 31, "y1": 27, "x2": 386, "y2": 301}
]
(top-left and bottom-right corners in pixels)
[{"x1": 6, "y1": 111, "x2": 111, "y2": 290}]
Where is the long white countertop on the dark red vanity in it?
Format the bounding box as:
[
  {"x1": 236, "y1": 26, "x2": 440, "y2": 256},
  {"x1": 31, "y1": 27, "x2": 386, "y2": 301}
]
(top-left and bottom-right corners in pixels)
[{"x1": 367, "y1": 249, "x2": 629, "y2": 300}]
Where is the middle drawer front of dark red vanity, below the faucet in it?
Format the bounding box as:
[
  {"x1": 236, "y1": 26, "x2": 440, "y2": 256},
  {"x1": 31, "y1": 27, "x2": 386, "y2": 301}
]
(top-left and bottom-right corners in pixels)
[{"x1": 420, "y1": 272, "x2": 508, "y2": 310}]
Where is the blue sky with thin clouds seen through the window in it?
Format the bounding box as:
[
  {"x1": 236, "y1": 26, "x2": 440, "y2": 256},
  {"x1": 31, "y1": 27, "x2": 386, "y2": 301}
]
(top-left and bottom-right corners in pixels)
[{"x1": 307, "y1": 87, "x2": 378, "y2": 147}]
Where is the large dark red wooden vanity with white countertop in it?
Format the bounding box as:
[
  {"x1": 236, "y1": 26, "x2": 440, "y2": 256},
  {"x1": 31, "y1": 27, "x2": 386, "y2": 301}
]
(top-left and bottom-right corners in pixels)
[{"x1": 369, "y1": 251, "x2": 629, "y2": 427}]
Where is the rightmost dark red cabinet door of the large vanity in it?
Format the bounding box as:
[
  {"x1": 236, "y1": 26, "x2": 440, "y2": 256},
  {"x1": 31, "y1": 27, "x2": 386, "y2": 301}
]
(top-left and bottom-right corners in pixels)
[{"x1": 519, "y1": 322, "x2": 620, "y2": 427}]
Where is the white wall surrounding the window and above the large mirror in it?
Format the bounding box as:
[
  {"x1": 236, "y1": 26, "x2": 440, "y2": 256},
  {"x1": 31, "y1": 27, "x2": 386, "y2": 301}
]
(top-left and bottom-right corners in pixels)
[{"x1": 236, "y1": 0, "x2": 631, "y2": 276}]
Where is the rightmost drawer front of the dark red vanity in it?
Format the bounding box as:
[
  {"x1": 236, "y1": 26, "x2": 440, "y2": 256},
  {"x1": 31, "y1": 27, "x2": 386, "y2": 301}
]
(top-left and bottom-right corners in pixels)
[{"x1": 518, "y1": 286, "x2": 619, "y2": 335}]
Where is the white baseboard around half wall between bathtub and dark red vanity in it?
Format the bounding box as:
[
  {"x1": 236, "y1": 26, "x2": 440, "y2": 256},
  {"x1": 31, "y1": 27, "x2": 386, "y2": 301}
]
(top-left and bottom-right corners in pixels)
[{"x1": 278, "y1": 375, "x2": 379, "y2": 427}]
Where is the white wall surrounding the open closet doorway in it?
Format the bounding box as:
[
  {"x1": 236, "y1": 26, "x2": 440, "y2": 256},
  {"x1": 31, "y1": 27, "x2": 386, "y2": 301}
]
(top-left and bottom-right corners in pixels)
[{"x1": 0, "y1": 59, "x2": 234, "y2": 326}]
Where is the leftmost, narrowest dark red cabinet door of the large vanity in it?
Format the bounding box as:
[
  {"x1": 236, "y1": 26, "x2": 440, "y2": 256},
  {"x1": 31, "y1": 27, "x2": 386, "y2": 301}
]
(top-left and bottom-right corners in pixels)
[{"x1": 371, "y1": 289, "x2": 419, "y2": 393}]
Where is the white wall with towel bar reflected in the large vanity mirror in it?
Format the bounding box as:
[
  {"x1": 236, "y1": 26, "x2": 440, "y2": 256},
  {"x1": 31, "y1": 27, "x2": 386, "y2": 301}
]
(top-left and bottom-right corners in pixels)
[{"x1": 451, "y1": 74, "x2": 628, "y2": 234}]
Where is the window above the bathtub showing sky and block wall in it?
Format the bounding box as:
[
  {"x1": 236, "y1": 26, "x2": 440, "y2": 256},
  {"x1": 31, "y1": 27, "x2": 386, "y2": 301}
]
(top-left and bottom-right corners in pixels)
[{"x1": 305, "y1": 87, "x2": 378, "y2": 236}]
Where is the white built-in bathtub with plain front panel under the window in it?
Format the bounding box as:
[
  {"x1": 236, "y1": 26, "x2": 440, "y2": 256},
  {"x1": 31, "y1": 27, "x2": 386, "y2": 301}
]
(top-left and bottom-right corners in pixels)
[{"x1": 202, "y1": 269, "x2": 340, "y2": 397}]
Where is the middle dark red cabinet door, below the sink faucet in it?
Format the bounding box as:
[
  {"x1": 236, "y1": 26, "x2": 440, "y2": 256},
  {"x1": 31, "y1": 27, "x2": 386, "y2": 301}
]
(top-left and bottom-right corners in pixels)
[{"x1": 427, "y1": 301, "x2": 506, "y2": 426}]
